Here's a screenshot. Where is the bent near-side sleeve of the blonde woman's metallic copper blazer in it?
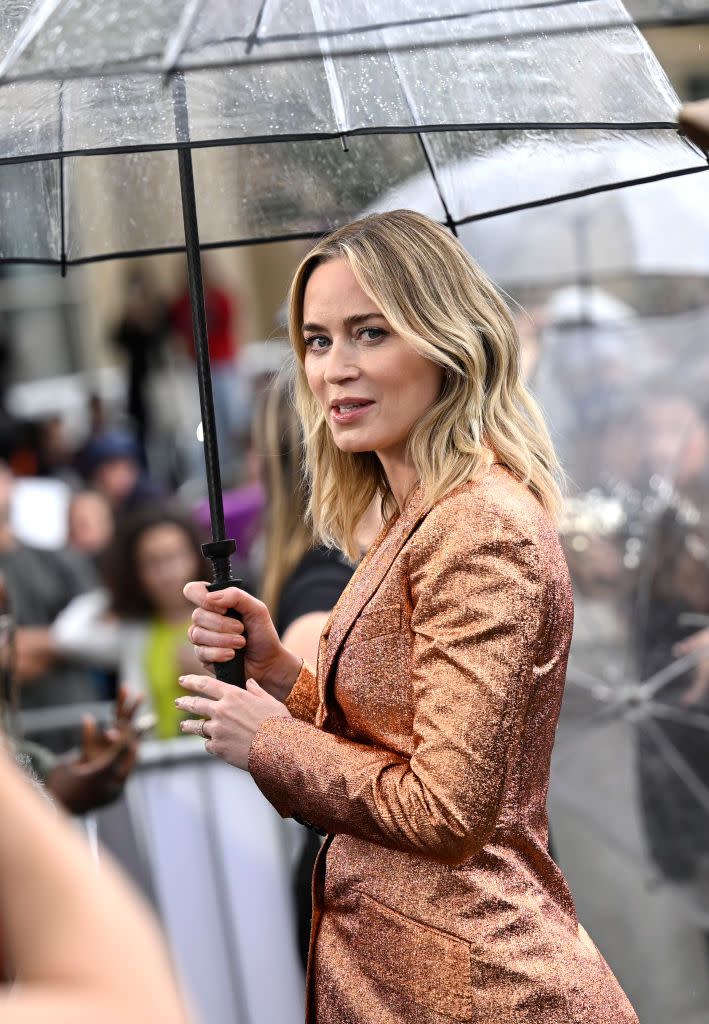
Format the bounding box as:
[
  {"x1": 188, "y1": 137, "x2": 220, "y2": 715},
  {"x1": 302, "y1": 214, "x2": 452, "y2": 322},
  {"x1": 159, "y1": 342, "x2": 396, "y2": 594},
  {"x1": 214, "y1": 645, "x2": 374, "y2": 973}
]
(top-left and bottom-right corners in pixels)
[{"x1": 249, "y1": 503, "x2": 544, "y2": 863}]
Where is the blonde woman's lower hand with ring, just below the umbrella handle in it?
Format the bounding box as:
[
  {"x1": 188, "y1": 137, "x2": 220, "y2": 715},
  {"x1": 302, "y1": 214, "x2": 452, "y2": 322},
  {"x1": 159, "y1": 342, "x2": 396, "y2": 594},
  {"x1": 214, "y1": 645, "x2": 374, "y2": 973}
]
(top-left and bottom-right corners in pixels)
[{"x1": 175, "y1": 676, "x2": 291, "y2": 771}]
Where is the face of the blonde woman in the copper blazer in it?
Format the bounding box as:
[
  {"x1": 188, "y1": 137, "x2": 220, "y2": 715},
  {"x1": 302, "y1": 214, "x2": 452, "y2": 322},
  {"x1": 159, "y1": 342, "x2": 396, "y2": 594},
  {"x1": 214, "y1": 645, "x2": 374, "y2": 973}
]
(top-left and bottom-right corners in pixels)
[{"x1": 303, "y1": 259, "x2": 443, "y2": 462}]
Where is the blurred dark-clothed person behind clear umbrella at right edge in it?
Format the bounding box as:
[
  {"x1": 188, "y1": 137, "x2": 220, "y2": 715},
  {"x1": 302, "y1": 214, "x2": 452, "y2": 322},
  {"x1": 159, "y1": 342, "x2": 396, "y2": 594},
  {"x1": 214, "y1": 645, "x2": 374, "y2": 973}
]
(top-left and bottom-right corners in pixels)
[{"x1": 633, "y1": 381, "x2": 709, "y2": 929}]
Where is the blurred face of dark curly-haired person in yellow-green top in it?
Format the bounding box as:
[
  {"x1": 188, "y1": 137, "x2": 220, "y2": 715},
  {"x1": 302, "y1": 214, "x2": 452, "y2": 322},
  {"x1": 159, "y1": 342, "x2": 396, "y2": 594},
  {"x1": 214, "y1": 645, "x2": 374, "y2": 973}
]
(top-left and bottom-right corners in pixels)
[{"x1": 135, "y1": 522, "x2": 199, "y2": 611}]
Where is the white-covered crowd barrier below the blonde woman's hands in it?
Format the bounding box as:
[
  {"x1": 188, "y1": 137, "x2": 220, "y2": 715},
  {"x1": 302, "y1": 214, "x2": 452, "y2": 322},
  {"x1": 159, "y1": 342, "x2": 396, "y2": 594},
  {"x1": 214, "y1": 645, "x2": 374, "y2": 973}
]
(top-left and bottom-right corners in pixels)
[{"x1": 90, "y1": 737, "x2": 304, "y2": 1024}]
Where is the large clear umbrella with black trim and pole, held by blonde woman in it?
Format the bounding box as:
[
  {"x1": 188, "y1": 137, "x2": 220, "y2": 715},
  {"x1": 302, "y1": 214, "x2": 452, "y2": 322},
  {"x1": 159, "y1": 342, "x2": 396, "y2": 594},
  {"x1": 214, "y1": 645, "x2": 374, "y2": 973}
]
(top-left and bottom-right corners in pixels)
[{"x1": 0, "y1": 0, "x2": 706, "y2": 681}]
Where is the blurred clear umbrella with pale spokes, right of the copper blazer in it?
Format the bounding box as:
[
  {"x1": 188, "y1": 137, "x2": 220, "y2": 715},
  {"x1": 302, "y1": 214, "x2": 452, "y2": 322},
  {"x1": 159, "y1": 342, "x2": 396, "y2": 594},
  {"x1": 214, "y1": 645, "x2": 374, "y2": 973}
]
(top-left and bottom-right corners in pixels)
[{"x1": 533, "y1": 305, "x2": 709, "y2": 1024}]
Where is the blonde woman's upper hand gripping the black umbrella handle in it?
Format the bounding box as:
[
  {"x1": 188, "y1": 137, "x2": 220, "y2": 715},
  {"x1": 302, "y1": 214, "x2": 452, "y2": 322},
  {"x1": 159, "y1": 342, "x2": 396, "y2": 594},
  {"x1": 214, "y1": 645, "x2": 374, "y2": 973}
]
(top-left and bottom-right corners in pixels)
[{"x1": 184, "y1": 583, "x2": 302, "y2": 700}]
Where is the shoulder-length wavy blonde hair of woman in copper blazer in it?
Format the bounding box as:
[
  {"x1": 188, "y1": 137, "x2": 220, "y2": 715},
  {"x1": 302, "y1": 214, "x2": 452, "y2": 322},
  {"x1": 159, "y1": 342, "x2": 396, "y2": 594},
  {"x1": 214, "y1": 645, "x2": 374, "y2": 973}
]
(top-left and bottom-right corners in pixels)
[{"x1": 289, "y1": 210, "x2": 562, "y2": 558}]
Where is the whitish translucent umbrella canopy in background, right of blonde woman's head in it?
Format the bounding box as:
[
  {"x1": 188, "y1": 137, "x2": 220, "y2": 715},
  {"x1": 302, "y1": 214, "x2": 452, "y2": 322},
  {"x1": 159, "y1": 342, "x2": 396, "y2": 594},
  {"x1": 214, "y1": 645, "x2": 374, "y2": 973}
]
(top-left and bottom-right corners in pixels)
[{"x1": 374, "y1": 144, "x2": 709, "y2": 289}]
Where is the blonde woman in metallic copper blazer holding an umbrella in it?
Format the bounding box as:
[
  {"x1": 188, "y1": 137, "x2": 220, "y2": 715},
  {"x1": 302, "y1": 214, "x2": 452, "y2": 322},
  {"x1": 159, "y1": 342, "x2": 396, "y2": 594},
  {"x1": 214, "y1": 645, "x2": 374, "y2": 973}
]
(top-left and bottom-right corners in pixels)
[{"x1": 178, "y1": 211, "x2": 636, "y2": 1024}]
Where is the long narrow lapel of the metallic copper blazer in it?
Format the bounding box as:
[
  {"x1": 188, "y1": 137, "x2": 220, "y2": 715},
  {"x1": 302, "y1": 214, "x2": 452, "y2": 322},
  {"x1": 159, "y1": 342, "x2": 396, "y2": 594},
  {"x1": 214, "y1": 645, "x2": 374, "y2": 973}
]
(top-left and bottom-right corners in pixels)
[{"x1": 316, "y1": 487, "x2": 429, "y2": 726}]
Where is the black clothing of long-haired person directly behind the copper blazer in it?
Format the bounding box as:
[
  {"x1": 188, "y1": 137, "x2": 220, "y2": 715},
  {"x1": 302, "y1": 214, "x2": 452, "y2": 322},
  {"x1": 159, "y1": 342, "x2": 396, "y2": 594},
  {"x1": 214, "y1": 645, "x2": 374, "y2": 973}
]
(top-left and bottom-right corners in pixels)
[{"x1": 276, "y1": 547, "x2": 355, "y2": 968}]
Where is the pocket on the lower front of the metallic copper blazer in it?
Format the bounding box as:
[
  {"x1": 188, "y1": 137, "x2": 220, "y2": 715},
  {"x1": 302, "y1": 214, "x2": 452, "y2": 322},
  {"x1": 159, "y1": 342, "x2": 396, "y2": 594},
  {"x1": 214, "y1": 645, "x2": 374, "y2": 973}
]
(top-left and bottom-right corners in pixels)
[{"x1": 359, "y1": 890, "x2": 472, "y2": 1021}]
